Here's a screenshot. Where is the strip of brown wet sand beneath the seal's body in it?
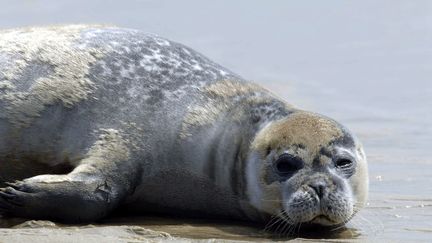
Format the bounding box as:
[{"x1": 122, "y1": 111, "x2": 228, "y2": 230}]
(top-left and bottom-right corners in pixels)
[{"x1": 0, "y1": 216, "x2": 359, "y2": 242}]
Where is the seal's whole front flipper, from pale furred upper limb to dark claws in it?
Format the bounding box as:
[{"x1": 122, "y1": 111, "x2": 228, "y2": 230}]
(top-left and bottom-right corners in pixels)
[{"x1": 0, "y1": 130, "x2": 140, "y2": 222}]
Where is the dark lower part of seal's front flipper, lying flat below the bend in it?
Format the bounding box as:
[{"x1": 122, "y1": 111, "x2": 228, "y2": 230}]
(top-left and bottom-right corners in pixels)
[{"x1": 0, "y1": 165, "x2": 136, "y2": 222}]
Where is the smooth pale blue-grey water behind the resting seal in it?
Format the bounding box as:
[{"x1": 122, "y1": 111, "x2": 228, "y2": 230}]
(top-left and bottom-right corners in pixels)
[{"x1": 0, "y1": 0, "x2": 432, "y2": 242}]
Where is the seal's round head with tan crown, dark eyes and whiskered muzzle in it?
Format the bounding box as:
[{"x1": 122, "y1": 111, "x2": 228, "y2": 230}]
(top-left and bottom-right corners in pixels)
[{"x1": 246, "y1": 111, "x2": 368, "y2": 229}]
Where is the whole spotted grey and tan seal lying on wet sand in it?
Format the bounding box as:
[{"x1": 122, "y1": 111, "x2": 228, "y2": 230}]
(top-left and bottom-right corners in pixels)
[{"x1": 0, "y1": 25, "x2": 368, "y2": 231}]
